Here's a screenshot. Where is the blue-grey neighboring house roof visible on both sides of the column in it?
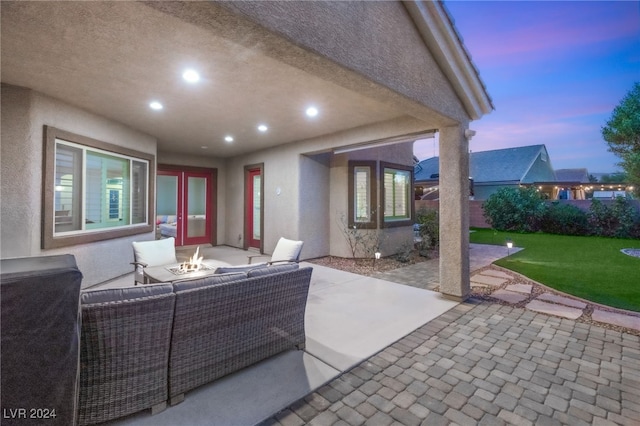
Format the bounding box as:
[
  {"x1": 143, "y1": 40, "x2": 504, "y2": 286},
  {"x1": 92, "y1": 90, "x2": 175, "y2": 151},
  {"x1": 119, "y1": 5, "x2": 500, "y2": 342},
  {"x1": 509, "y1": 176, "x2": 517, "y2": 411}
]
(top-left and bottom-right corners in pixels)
[{"x1": 414, "y1": 145, "x2": 556, "y2": 184}]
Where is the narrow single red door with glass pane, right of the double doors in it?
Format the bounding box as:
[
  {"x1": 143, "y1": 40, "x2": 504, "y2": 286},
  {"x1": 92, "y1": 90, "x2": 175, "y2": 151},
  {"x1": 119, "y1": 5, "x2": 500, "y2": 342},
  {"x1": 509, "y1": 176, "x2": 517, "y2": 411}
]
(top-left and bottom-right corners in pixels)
[{"x1": 244, "y1": 165, "x2": 263, "y2": 252}]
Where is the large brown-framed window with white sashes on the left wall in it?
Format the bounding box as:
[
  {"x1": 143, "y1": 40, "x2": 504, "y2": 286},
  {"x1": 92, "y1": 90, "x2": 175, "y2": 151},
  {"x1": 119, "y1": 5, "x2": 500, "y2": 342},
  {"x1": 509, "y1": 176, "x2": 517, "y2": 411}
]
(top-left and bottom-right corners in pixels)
[{"x1": 43, "y1": 127, "x2": 155, "y2": 248}]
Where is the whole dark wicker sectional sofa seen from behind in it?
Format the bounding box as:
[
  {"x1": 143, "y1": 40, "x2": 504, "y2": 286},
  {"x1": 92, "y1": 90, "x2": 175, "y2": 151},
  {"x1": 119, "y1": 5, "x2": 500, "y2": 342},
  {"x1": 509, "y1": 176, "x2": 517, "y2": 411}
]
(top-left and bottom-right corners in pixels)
[{"x1": 78, "y1": 263, "x2": 312, "y2": 425}]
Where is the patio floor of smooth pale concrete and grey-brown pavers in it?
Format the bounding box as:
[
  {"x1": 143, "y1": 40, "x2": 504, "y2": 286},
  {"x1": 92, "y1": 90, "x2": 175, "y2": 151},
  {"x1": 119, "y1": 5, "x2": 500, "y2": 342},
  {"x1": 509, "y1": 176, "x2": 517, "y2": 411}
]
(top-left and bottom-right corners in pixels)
[{"x1": 96, "y1": 245, "x2": 640, "y2": 426}]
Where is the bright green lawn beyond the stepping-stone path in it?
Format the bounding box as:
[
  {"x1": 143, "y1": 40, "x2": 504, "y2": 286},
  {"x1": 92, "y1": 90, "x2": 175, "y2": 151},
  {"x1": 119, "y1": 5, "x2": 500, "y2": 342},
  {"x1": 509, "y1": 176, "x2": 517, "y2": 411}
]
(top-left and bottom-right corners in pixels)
[{"x1": 471, "y1": 229, "x2": 640, "y2": 312}]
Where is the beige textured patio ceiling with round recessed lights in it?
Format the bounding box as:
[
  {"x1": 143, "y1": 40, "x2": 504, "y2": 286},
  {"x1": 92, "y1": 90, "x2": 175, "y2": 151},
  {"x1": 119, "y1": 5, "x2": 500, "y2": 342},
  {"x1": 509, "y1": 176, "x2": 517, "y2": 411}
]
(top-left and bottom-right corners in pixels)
[{"x1": 1, "y1": 1, "x2": 403, "y2": 157}]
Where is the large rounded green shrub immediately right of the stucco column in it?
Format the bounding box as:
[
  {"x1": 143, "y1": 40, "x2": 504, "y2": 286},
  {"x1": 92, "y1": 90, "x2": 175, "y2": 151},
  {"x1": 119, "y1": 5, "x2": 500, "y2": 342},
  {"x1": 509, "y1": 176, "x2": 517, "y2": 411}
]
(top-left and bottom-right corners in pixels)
[{"x1": 482, "y1": 187, "x2": 546, "y2": 232}]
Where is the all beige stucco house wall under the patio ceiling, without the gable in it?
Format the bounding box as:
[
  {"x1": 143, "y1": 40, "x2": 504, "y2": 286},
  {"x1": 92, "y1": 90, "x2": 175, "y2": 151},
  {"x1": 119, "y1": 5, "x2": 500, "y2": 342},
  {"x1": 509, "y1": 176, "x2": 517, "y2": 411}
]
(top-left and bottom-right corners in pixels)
[{"x1": 2, "y1": 86, "x2": 440, "y2": 286}]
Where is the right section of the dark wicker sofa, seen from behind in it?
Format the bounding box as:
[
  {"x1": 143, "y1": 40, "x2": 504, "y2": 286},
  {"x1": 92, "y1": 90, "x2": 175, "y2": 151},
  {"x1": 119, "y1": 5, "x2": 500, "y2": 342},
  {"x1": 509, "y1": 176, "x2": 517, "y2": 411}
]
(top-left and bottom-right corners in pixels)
[{"x1": 169, "y1": 263, "x2": 312, "y2": 405}]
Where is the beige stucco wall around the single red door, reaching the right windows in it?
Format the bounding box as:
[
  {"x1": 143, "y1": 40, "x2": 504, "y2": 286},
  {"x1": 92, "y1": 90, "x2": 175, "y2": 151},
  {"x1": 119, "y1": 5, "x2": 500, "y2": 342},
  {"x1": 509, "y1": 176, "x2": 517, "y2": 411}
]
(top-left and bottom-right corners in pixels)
[{"x1": 218, "y1": 117, "x2": 430, "y2": 259}]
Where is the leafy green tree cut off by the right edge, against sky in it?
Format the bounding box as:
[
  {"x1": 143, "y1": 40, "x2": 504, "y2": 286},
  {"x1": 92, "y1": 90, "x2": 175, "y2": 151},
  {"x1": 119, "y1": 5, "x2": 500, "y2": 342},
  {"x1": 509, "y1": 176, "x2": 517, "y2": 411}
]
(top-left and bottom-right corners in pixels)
[{"x1": 602, "y1": 82, "x2": 640, "y2": 195}]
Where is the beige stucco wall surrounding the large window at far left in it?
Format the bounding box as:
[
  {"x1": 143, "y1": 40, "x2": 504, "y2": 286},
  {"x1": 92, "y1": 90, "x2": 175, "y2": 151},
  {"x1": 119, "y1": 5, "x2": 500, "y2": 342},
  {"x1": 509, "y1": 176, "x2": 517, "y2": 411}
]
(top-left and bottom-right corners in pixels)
[{"x1": 0, "y1": 85, "x2": 156, "y2": 287}]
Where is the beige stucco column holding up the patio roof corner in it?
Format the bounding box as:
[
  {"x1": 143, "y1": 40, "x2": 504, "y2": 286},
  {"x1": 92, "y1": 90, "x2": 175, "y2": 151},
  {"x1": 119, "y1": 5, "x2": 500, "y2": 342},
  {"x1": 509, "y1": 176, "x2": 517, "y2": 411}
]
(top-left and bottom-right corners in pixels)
[{"x1": 440, "y1": 125, "x2": 470, "y2": 300}]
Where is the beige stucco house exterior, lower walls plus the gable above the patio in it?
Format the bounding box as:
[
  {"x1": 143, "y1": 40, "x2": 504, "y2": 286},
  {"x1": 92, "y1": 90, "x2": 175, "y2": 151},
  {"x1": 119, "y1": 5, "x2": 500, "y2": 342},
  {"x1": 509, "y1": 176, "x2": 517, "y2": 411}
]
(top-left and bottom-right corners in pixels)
[{"x1": 2, "y1": 2, "x2": 484, "y2": 287}]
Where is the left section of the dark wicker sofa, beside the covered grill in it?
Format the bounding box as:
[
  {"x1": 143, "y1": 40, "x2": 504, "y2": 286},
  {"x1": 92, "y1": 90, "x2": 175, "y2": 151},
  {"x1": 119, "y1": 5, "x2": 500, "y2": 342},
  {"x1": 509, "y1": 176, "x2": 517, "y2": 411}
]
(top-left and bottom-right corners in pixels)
[{"x1": 78, "y1": 284, "x2": 175, "y2": 425}]
